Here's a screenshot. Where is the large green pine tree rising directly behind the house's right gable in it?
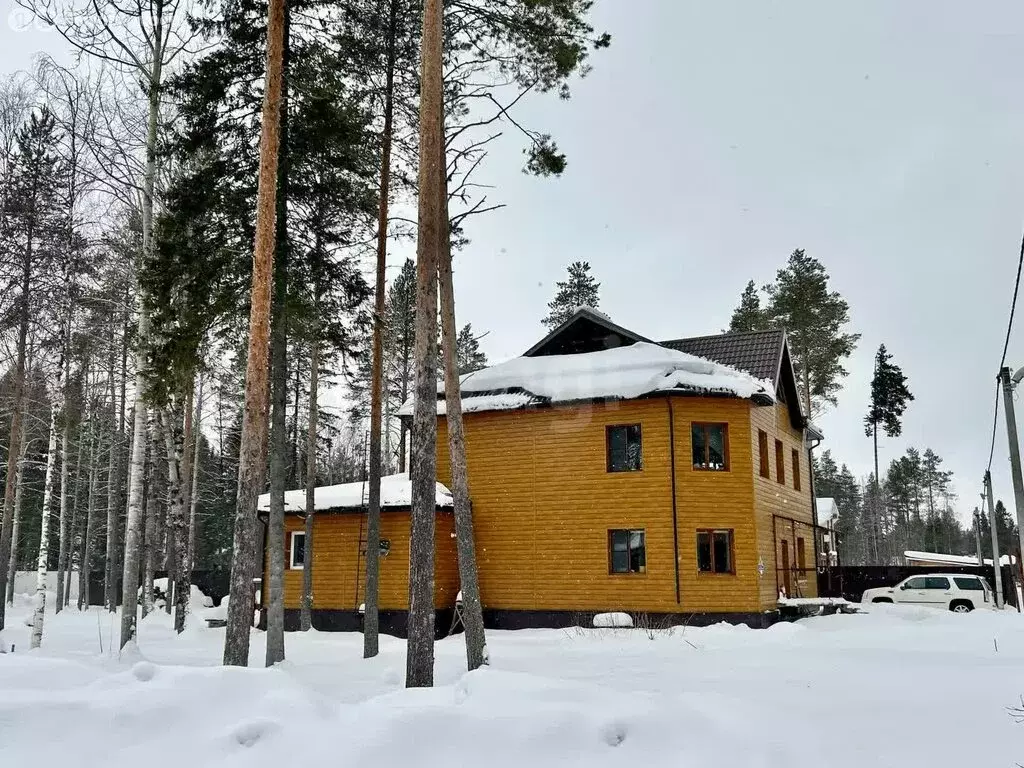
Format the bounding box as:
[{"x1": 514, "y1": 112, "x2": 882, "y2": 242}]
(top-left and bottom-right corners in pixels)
[{"x1": 765, "y1": 249, "x2": 860, "y2": 416}]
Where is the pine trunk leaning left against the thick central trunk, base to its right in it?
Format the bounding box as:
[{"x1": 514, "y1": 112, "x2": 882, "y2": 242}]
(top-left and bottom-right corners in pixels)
[{"x1": 437, "y1": 159, "x2": 487, "y2": 672}]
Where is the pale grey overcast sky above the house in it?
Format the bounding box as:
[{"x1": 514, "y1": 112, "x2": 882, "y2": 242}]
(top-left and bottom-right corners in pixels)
[{"x1": 6, "y1": 0, "x2": 1024, "y2": 524}]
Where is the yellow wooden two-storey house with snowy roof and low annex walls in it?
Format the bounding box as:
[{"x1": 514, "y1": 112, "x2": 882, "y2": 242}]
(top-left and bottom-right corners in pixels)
[{"x1": 264, "y1": 309, "x2": 820, "y2": 629}]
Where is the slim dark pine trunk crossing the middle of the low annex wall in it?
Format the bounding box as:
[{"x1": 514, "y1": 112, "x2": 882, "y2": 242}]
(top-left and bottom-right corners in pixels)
[{"x1": 364, "y1": 0, "x2": 398, "y2": 658}]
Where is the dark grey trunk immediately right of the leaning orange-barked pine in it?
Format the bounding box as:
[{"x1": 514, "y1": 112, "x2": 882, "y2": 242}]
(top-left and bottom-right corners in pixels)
[{"x1": 263, "y1": 4, "x2": 291, "y2": 667}]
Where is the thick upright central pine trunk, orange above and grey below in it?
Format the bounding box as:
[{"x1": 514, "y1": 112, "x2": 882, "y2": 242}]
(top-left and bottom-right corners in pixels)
[{"x1": 406, "y1": 0, "x2": 446, "y2": 688}]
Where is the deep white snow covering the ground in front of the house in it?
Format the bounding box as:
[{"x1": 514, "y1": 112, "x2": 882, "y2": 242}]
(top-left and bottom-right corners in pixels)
[{"x1": 0, "y1": 605, "x2": 1024, "y2": 768}]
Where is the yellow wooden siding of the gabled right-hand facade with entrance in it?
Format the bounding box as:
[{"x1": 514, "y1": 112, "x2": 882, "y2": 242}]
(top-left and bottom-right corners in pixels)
[{"x1": 750, "y1": 402, "x2": 817, "y2": 608}]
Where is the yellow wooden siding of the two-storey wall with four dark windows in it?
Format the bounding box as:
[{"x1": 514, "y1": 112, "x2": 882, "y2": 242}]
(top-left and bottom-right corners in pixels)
[{"x1": 438, "y1": 397, "x2": 759, "y2": 611}]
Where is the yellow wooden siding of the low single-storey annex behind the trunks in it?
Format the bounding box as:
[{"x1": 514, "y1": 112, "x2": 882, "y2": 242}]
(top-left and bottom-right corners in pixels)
[{"x1": 264, "y1": 512, "x2": 459, "y2": 610}]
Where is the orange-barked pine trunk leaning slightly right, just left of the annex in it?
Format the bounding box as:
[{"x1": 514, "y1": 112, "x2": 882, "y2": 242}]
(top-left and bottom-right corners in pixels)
[{"x1": 224, "y1": 0, "x2": 286, "y2": 667}]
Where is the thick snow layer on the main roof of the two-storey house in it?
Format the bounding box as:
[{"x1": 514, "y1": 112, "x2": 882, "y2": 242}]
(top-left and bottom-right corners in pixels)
[{"x1": 398, "y1": 342, "x2": 774, "y2": 416}]
